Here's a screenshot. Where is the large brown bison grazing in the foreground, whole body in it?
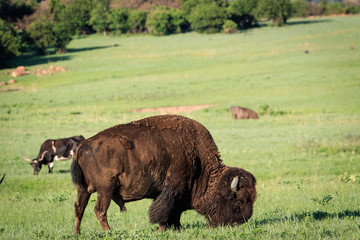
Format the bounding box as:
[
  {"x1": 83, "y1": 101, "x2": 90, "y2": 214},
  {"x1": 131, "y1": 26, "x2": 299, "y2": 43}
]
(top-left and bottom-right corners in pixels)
[{"x1": 71, "y1": 115, "x2": 256, "y2": 233}]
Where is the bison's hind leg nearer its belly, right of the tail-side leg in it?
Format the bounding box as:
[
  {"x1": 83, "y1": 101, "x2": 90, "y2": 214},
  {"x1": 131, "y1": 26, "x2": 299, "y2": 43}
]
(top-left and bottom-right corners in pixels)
[{"x1": 94, "y1": 191, "x2": 112, "y2": 231}]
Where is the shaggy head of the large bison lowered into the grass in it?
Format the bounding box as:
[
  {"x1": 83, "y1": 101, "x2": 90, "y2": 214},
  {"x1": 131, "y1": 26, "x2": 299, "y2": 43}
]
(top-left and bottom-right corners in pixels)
[{"x1": 207, "y1": 167, "x2": 256, "y2": 226}]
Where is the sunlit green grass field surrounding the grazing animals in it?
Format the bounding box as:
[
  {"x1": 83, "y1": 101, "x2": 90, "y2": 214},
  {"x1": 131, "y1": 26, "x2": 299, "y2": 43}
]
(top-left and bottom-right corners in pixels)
[{"x1": 0, "y1": 16, "x2": 360, "y2": 239}]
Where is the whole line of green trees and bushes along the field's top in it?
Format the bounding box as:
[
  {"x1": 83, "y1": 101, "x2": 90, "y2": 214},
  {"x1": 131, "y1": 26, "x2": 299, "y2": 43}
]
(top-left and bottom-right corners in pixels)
[{"x1": 0, "y1": 0, "x2": 360, "y2": 64}]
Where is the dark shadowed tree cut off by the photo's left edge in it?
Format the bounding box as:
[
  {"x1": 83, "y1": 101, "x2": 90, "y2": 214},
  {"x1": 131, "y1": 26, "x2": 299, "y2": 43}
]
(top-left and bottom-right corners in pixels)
[{"x1": 0, "y1": 19, "x2": 22, "y2": 66}]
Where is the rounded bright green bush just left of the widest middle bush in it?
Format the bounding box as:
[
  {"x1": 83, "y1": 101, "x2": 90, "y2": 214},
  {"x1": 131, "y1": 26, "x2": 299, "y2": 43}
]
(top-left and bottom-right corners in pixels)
[{"x1": 146, "y1": 7, "x2": 176, "y2": 36}]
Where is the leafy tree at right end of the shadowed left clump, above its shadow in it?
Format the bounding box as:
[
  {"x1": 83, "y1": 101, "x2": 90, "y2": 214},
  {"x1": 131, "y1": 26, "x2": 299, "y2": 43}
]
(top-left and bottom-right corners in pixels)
[{"x1": 28, "y1": 19, "x2": 56, "y2": 55}]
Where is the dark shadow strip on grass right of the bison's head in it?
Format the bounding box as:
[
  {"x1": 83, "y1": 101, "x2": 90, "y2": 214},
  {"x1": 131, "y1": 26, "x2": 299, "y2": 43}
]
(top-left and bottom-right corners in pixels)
[{"x1": 255, "y1": 210, "x2": 360, "y2": 225}]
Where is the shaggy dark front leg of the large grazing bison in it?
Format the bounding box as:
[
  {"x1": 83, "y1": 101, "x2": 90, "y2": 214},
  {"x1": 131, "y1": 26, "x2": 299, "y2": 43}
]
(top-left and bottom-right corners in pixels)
[{"x1": 149, "y1": 187, "x2": 182, "y2": 231}]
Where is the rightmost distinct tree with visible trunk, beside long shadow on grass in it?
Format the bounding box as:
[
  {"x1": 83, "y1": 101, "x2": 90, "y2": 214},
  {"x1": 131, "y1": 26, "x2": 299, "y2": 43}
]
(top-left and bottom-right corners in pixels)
[{"x1": 258, "y1": 0, "x2": 291, "y2": 26}]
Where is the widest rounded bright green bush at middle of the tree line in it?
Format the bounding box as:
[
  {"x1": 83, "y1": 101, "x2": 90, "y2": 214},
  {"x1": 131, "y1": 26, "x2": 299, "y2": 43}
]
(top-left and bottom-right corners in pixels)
[{"x1": 189, "y1": 2, "x2": 226, "y2": 33}]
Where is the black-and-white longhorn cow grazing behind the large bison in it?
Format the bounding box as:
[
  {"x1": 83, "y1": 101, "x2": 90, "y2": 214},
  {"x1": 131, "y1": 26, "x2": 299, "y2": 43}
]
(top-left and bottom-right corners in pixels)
[{"x1": 23, "y1": 136, "x2": 85, "y2": 175}]
